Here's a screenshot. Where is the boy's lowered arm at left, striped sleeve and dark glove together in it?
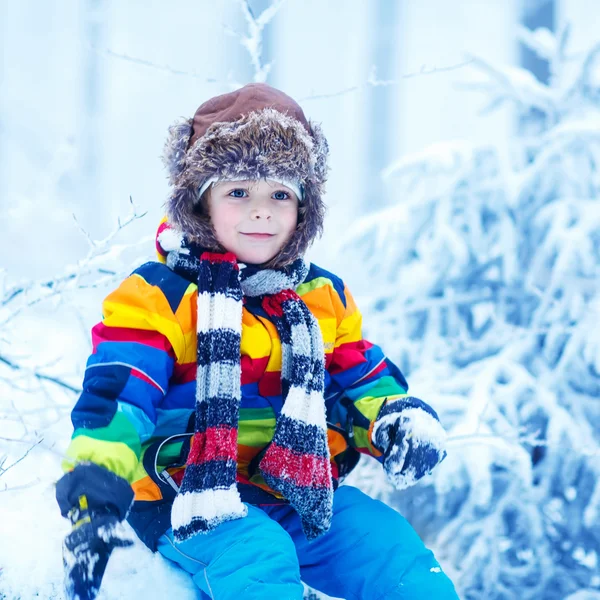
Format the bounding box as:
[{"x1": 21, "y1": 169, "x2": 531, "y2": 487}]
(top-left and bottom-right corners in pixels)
[{"x1": 56, "y1": 263, "x2": 193, "y2": 599}]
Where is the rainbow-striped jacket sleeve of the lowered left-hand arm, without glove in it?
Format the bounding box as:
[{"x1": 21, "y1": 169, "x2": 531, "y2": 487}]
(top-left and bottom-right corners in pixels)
[{"x1": 63, "y1": 263, "x2": 188, "y2": 483}]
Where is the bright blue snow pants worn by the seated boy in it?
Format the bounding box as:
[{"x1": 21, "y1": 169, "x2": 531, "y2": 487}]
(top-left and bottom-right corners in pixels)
[{"x1": 158, "y1": 486, "x2": 459, "y2": 600}]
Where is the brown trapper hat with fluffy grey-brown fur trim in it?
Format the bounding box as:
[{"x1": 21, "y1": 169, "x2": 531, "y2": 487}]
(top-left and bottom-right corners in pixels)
[{"x1": 163, "y1": 83, "x2": 329, "y2": 267}]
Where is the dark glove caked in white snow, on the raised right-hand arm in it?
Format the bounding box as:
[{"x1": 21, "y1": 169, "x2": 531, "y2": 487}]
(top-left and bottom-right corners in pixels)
[{"x1": 371, "y1": 396, "x2": 446, "y2": 490}]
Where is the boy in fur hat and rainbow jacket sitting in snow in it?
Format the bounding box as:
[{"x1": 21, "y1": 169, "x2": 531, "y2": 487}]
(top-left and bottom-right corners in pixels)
[{"x1": 57, "y1": 84, "x2": 457, "y2": 600}]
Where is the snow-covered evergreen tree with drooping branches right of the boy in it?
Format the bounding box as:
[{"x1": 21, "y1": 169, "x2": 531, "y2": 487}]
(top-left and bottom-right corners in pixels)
[{"x1": 343, "y1": 29, "x2": 600, "y2": 600}]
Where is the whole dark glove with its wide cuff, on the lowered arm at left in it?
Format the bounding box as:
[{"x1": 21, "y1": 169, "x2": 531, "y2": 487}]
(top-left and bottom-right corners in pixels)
[{"x1": 56, "y1": 463, "x2": 133, "y2": 600}]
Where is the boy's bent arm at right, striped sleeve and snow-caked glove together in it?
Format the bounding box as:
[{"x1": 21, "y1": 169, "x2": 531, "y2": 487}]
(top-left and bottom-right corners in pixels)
[{"x1": 327, "y1": 287, "x2": 445, "y2": 488}]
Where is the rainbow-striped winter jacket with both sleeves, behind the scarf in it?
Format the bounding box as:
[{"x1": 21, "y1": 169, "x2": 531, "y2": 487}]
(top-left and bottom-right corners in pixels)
[{"x1": 63, "y1": 262, "x2": 408, "y2": 549}]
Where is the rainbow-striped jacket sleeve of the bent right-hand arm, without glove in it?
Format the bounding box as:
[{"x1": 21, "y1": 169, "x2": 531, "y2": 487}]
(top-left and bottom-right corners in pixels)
[{"x1": 326, "y1": 286, "x2": 408, "y2": 459}]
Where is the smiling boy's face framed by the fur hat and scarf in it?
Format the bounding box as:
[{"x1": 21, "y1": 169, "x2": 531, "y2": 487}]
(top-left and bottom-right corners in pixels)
[{"x1": 207, "y1": 179, "x2": 298, "y2": 265}]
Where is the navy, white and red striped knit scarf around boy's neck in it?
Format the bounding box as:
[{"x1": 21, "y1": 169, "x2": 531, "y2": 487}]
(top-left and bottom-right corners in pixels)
[{"x1": 159, "y1": 232, "x2": 333, "y2": 541}]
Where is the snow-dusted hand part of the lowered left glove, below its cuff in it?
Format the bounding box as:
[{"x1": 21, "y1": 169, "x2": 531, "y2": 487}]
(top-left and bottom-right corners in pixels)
[{"x1": 63, "y1": 496, "x2": 133, "y2": 600}]
